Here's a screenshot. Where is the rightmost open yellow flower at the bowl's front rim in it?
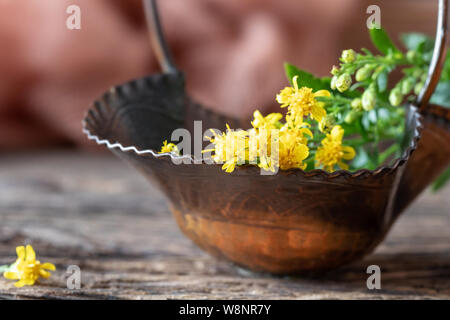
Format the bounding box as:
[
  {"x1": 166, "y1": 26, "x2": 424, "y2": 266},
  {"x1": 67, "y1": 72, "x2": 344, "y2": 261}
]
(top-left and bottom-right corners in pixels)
[{"x1": 315, "y1": 126, "x2": 355, "y2": 172}]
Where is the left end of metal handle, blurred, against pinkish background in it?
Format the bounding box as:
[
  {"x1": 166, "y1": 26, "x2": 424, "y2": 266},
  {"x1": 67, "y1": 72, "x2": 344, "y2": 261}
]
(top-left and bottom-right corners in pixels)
[{"x1": 143, "y1": 0, "x2": 178, "y2": 73}]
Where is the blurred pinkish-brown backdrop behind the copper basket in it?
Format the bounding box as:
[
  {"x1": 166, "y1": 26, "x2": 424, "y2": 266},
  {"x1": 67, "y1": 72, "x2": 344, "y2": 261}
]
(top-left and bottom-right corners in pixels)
[{"x1": 0, "y1": 0, "x2": 437, "y2": 152}]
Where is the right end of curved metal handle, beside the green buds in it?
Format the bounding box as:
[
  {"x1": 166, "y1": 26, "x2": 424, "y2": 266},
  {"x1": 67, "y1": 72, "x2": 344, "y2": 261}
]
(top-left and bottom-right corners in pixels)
[{"x1": 416, "y1": 0, "x2": 448, "y2": 112}]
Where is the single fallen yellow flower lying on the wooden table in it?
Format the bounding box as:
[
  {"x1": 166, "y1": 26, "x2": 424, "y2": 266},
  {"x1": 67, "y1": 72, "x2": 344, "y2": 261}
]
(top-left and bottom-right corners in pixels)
[{"x1": 3, "y1": 245, "x2": 56, "y2": 288}]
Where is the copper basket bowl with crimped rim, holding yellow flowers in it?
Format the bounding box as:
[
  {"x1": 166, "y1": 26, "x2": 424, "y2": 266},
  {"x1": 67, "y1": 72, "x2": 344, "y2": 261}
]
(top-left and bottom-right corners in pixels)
[{"x1": 84, "y1": 73, "x2": 428, "y2": 274}]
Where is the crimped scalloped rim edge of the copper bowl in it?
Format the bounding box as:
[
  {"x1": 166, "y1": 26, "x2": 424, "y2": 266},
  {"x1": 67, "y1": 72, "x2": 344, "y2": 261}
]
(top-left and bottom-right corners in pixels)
[{"x1": 82, "y1": 80, "x2": 423, "y2": 178}]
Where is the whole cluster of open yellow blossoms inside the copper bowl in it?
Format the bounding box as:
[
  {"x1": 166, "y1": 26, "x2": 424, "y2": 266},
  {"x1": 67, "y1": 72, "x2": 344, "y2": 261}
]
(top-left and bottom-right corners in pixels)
[{"x1": 161, "y1": 76, "x2": 355, "y2": 172}]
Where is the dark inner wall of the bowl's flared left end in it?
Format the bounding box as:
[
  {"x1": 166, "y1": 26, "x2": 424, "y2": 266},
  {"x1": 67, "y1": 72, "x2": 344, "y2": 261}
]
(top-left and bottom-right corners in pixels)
[{"x1": 84, "y1": 73, "x2": 246, "y2": 155}]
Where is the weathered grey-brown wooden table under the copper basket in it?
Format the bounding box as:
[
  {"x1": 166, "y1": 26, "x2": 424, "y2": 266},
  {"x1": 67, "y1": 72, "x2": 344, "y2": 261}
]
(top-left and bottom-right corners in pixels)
[{"x1": 0, "y1": 152, "x2": 450, "y2": 299}]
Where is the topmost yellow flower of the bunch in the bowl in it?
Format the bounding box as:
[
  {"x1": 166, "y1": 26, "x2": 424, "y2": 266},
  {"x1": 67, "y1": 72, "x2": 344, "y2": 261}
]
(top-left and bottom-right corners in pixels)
[{"x1": 276, "y1": 76, "x2": 331, "y2": 125}]
